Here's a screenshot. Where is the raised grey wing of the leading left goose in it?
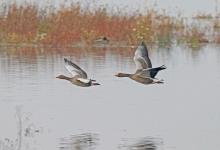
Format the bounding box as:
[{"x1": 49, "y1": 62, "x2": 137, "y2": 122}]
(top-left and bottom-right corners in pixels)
[{"x1": 64, "y1": 58, "x2": 87, "y2": 79}]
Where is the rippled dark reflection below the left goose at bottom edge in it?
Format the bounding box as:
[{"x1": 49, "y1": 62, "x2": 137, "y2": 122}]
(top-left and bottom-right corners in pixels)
[{"x1": 60, "y1": 133, "x2": 99, "y2": 150}]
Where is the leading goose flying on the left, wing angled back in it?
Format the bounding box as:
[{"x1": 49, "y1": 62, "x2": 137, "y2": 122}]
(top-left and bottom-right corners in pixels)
[{"x1": 56, "y1": 58, "x2": 100, "y2": 87}]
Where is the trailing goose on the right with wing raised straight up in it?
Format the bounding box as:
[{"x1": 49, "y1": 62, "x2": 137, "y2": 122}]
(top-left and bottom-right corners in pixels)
[{"x1": 115, "y1": 42, "x2": 166, "y2": 84}]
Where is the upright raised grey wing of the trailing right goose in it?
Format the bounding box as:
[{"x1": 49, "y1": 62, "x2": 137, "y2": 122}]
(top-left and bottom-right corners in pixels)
[{"x1": 134, "y1": 42, "x2": 152, "y2": 70}]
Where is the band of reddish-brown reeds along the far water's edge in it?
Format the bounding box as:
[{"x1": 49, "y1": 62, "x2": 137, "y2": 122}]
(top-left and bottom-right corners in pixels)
[{"x1": 0, "y1": 3, "x2": 220, "y2": 47}]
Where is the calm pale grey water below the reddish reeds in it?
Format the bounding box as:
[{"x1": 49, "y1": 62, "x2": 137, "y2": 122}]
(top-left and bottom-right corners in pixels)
[{"x1": 0, "y1": 46, "x2": 220, "y2": 150}]
